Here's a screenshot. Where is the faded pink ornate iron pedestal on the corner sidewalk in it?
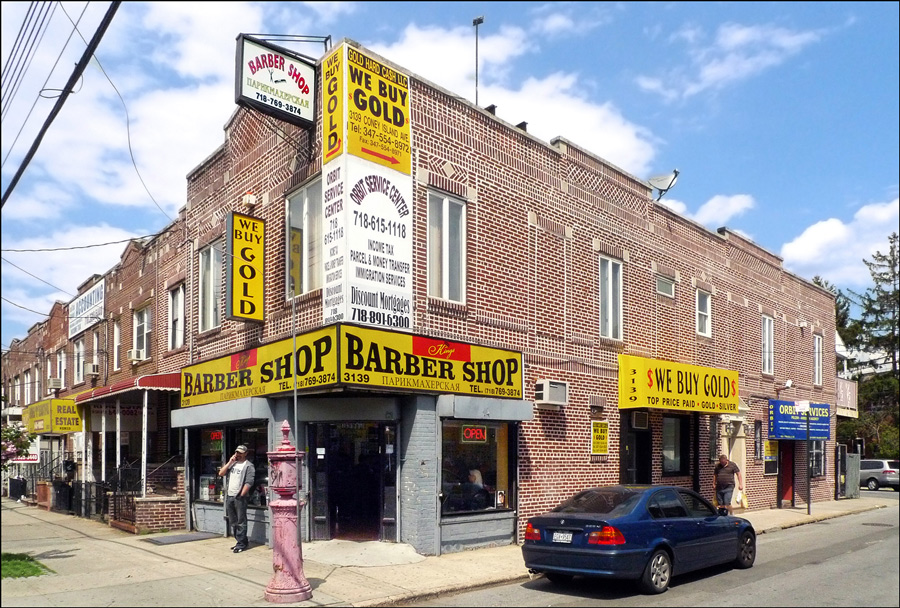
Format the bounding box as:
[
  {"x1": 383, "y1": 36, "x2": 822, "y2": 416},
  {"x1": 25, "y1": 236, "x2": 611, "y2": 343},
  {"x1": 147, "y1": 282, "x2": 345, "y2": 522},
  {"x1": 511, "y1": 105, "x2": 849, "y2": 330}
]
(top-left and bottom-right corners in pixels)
[{"x1": 265, "y1": 420, "x2": 312, "y2": 604}]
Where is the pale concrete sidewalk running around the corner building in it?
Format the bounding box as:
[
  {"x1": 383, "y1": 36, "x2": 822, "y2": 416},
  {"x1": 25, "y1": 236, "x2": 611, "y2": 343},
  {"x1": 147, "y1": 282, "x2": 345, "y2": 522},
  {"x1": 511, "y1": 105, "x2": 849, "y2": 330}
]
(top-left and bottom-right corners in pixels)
[{"x1": 0, "y1": 496, "x2": 897, "y2": 607}]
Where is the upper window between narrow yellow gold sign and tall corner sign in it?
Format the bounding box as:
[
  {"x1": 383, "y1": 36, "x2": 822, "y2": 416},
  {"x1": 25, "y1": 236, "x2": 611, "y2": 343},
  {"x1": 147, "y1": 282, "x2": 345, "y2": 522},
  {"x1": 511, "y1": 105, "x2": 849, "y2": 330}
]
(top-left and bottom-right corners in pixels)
[{"x1": 285, "y1": 177, "x2": 324, "y2": 298}]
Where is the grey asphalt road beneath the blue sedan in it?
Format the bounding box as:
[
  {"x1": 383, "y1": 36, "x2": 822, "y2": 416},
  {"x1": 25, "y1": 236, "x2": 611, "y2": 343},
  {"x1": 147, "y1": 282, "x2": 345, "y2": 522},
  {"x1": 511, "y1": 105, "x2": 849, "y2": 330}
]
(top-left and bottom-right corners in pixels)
[{"x1": 413, "y1": 504, "x2": 900, "y2": 607}]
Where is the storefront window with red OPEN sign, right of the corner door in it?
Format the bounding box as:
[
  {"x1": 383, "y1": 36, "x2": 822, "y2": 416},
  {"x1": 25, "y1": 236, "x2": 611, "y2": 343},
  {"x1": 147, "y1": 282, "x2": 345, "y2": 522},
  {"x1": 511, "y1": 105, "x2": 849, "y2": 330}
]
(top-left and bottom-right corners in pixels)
[{"x1": 441, "y1": 420, "x2": 515, "y2": 515}]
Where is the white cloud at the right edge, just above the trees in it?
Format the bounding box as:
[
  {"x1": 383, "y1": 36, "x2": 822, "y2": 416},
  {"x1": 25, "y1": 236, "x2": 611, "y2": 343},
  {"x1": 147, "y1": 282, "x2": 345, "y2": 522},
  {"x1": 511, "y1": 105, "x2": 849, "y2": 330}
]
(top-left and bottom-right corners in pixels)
[{"x1": 781, "y1": 198, "x2": 900, "y2": 289}]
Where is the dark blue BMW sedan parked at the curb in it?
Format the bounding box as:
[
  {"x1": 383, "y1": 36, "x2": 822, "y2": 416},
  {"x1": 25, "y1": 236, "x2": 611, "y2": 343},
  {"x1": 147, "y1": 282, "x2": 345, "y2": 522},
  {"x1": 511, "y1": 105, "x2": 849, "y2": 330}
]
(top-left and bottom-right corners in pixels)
[{"x1": 522, "y1": 485, "x2": 756, "y2": 593}]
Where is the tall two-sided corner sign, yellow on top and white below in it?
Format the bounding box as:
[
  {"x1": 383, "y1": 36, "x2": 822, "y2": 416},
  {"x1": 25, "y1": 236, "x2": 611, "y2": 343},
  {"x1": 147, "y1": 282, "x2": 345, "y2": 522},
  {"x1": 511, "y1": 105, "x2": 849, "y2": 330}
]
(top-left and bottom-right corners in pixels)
[{"x1": 322, "y1": 44, "x2": 412, "y2": 331}]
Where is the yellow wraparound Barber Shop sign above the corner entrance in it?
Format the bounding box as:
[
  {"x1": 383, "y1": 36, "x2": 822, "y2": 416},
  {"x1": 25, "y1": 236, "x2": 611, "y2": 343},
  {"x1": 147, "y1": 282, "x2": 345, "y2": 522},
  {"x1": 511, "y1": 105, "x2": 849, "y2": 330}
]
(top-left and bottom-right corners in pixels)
[{"x1": 181, "y1": 324, "x2": 522, "y2": 407}]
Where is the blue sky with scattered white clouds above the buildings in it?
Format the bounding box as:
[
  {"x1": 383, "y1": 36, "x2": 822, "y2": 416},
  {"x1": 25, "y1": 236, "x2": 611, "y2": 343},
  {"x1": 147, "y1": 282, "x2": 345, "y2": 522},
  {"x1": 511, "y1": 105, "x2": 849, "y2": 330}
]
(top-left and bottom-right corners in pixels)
[{"x1": 0, "y1": 2, "x2": 900, "y2": 349}]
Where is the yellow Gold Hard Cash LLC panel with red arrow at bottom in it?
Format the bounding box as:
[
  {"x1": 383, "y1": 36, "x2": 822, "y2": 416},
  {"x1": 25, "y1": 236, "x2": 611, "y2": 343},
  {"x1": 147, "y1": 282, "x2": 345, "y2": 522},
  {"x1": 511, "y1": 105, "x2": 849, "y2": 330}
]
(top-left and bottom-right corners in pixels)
[{"x1": 346, "y1": 47, "x2": 411, "y2": 175}]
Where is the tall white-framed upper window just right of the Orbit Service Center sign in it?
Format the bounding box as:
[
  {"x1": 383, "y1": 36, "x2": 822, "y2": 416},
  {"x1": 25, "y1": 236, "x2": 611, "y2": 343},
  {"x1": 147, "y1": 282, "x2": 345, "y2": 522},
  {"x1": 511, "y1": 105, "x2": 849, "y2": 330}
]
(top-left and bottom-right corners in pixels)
[{"x1": 426, "y1": 192, "x2": 466, "y2": 304}]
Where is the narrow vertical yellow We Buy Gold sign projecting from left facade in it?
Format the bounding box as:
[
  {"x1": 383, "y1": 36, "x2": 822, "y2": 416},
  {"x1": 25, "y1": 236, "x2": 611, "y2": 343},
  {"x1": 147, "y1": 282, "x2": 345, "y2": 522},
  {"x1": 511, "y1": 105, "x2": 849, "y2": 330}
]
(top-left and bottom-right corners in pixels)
[{"x1": 225, "y1": 213, "x2": 266, "y2": 321}]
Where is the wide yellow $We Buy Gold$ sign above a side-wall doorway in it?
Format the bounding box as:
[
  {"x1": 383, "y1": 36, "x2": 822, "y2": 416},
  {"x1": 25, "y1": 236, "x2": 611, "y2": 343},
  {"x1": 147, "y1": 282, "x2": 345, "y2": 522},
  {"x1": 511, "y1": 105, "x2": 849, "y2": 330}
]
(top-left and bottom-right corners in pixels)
[{"x1": 619, "y1": 355, "x2": 740, "y2": 414}]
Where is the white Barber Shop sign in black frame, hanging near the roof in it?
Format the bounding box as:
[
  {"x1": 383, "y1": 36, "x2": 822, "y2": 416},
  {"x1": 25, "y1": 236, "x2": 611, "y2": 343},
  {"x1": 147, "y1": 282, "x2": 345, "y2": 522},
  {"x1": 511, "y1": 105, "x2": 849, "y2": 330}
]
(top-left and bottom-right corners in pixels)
[{"x1": 234, "y1": 34, "x2": 316, "y2": 127}]
